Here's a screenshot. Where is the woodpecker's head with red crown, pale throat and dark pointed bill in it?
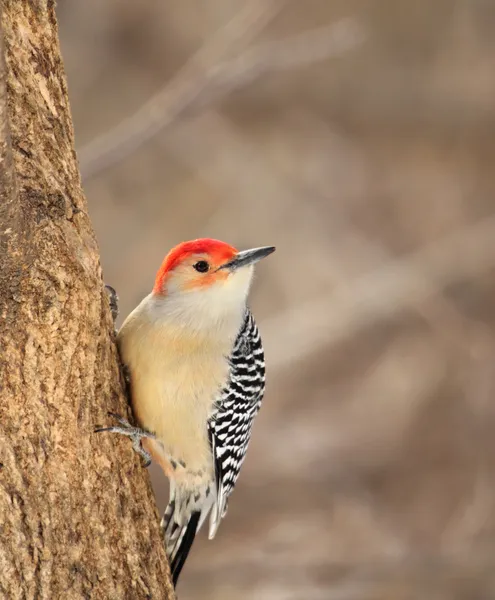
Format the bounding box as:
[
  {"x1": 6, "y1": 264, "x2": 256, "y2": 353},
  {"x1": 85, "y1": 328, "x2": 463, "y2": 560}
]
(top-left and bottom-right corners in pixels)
[{"x1": 153, "y1": 238, "x2": 275, "y2": 328}]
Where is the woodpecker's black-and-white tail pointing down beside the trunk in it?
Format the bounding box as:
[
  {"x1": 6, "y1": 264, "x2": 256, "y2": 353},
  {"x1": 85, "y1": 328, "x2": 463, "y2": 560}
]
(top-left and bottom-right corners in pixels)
[{"x1": 161, "y1": 481, "x2": 211, "y2": 586}]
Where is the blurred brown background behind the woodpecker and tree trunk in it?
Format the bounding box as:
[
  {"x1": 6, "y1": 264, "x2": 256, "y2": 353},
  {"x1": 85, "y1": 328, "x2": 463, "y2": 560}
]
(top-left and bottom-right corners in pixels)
[{"x1": 58, "y1": 0, "x2": 495, "y2": 600}]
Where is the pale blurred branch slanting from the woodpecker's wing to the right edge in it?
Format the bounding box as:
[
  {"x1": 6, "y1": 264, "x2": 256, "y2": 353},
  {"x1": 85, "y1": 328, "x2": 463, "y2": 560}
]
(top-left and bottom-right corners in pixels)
[{"x1": 262, "y1": 216, "x2": 495, "y2": 369}]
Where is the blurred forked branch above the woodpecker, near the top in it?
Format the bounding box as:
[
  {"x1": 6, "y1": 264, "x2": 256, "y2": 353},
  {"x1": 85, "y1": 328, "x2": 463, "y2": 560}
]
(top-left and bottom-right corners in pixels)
[{"x1": 79, "y1": 14, "x2": 365, "y2": 181}]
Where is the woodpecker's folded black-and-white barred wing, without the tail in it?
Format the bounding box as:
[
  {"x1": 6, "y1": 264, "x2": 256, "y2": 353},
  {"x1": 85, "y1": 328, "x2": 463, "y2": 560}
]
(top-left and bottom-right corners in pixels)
[{"x1": 208, "y1": 311, "x2": 265, "y2": 539}]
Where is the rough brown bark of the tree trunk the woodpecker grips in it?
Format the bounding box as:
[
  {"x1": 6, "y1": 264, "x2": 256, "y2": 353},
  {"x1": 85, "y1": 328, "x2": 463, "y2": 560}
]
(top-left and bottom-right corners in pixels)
[{"x1": 0, "y1": 0, "x2": 174, "y2": 600}]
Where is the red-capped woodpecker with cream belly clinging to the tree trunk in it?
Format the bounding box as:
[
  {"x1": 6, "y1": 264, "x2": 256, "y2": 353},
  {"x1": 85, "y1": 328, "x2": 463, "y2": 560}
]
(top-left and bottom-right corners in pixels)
[{"x1": 97, "y1": 238, "x2": 275, "y2": 585}]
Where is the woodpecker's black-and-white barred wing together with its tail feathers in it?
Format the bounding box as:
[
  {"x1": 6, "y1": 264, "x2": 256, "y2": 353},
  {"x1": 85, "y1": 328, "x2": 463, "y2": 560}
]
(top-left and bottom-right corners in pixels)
[{"x1": 162, "y1": 310, "x2": 265, "y2": 585}]
